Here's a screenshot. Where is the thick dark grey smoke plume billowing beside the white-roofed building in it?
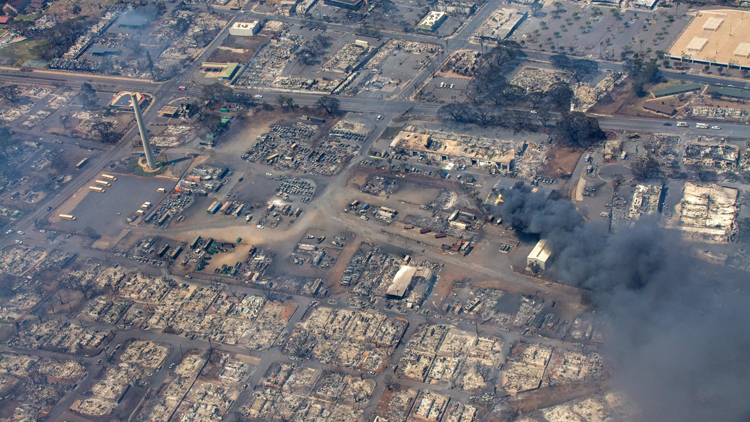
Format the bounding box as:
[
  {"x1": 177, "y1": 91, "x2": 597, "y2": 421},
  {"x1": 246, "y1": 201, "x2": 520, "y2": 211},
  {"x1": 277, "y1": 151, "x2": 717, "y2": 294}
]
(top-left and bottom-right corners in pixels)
[{"x1": 501, "y1": 184, "x2": 750, "y2": 422}]
